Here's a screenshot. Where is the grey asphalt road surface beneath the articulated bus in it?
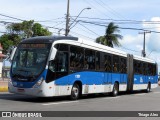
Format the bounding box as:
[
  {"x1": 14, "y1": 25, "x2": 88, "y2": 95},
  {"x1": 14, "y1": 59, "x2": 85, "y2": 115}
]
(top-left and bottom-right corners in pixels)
[{"x1": 0, "y1": 87, "x2": 160, "y2": 120}]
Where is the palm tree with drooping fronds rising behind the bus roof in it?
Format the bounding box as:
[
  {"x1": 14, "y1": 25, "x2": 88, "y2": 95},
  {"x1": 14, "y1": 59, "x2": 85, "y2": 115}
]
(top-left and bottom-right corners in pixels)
[{"x1": 96, "y1": 22, "x2": 123, "y2": 47}]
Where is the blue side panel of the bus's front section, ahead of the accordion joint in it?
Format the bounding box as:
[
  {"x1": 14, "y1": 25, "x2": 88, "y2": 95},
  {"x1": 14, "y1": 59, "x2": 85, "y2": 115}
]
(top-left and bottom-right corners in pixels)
[{"x1": 55, "y1": 71, "x2": 127, "y2": 85}]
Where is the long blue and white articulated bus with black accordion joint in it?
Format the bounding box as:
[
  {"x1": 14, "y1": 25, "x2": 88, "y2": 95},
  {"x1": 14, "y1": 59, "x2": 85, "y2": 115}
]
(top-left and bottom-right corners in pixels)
[{"x1": 8, "y1": 36, "x2": 158, "y2": 100}]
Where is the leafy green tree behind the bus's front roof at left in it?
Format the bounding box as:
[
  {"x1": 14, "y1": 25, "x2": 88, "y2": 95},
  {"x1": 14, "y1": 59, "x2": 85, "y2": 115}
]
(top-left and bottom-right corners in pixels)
[{"x1": 0, "y1": 20, "x2": 52, "y2": 54}]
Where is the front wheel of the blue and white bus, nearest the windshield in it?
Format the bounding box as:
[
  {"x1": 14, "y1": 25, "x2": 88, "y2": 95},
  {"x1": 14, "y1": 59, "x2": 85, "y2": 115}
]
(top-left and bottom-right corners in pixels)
[{"x1": 70, "y1": 83, "x2": 80, "y2": 100}]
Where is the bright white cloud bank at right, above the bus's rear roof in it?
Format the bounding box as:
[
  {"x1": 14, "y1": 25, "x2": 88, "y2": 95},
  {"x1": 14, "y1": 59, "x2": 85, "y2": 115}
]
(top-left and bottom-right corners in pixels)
[{"x1": 120, "y1": 17, "x2": 160, "y2": 69}]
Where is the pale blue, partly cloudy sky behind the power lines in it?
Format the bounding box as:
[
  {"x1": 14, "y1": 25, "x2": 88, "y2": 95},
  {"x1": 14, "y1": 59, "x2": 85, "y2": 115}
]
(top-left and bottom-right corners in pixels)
[{"x1": 0, "y1": 0, "x2": 160, "y2": 67}]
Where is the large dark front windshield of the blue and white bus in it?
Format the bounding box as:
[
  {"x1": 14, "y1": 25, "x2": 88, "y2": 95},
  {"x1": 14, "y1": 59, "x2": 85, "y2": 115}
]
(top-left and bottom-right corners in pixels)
[{"x1": 11, "y1": 44, "x2": 51, "y2": 81}]
